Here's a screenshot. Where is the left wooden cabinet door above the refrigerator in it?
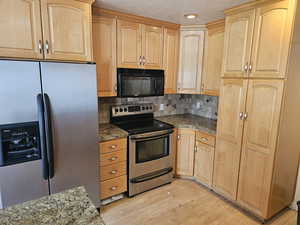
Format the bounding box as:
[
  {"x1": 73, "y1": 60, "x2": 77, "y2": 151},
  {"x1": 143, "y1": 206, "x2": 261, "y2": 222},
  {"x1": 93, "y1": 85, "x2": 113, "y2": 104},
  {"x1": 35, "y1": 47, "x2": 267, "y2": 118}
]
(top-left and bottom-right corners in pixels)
[{"x1": 0, "y1": 0, "x2": 43, "y2": 59}]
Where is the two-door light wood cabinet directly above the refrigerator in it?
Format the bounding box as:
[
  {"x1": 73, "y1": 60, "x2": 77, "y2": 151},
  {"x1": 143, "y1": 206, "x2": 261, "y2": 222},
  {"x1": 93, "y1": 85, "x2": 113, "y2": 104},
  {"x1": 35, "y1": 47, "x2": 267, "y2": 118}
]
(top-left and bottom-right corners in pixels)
[{"x1": 0, "y1": 0, "x2": 92, "y2": 61}]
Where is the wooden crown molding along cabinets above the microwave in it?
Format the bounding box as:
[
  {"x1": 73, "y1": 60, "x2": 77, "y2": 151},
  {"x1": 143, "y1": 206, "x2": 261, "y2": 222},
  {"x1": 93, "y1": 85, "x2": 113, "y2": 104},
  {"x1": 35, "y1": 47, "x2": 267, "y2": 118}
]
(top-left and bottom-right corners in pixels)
[{"x1": 93, "y1": 6, "x2": 180, "y2": 30}]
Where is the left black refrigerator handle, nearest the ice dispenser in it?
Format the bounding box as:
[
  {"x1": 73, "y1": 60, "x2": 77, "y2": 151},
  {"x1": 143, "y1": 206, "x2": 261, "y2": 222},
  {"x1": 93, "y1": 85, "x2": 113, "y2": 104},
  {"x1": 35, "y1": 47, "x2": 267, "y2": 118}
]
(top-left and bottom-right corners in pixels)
[{"x1": 37, "y1": 94, "x2": 49, "y2": 180}]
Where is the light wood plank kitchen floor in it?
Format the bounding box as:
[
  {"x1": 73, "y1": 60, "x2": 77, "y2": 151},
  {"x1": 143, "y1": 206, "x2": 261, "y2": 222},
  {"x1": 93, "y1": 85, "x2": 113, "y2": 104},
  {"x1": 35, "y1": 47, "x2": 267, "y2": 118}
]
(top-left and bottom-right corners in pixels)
[{"x1": 101, "y1": 179, "x2": 297, "y2": 225}]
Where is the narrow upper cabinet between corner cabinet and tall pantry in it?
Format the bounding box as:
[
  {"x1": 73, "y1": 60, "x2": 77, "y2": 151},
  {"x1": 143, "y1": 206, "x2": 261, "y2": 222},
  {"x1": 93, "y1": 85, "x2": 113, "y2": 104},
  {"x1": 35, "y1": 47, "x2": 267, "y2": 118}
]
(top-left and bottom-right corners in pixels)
[{"x1": 201, "y1": 20, "x2": 225, "y2": 96}]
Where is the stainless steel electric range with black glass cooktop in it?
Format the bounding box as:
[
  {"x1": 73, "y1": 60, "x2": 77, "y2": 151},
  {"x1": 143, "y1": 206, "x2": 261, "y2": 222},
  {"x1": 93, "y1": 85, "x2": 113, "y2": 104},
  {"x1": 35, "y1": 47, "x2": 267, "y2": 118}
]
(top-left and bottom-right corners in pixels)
[{"x1": 111, "y1": 104, "x2": 174, "y2": 196}]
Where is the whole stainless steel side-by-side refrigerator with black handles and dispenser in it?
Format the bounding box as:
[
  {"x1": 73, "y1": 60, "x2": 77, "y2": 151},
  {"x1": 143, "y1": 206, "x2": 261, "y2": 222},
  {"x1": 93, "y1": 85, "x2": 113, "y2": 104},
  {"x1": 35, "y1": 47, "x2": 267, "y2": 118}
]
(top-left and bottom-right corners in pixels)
[{"x1": 0, "y1": 60, "x2": 100, "y2": 208}]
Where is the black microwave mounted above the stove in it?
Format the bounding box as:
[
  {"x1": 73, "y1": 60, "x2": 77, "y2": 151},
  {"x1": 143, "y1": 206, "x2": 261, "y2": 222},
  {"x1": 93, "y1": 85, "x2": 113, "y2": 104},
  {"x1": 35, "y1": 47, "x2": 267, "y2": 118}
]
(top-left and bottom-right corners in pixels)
[{"x1": 117, "y1": 68, "x2": 165, "y2": 97}]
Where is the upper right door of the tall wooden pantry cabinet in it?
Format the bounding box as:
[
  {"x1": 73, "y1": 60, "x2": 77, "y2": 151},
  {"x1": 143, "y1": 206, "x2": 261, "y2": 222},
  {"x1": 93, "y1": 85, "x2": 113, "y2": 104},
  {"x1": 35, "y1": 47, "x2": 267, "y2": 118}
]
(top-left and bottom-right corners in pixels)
[{"x1": 250, "y1": 1, "x2": 294, "y2": 78}]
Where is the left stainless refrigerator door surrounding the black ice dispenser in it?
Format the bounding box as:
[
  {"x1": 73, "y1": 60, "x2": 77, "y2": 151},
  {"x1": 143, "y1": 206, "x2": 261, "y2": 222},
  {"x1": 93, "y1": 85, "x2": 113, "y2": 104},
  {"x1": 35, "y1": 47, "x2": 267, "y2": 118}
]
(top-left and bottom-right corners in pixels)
[{"x1": 0, "y1": 60, "x2": 49, "y2": 208}]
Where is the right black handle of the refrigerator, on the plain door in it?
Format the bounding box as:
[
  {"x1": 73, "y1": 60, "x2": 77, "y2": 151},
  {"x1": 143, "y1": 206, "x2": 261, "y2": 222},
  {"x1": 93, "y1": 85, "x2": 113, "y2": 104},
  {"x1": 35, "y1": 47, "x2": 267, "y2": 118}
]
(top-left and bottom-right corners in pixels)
[{"x1": 44, "y1": 93, "x2": 54, "y2": 179}]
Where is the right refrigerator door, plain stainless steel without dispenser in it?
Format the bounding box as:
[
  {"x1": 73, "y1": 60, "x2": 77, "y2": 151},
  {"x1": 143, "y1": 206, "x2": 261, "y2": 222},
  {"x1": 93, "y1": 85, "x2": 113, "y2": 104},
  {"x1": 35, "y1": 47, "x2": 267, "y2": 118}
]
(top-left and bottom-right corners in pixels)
[{"x1": 41, "y1": 62, "x2": 100, "y2": 207}]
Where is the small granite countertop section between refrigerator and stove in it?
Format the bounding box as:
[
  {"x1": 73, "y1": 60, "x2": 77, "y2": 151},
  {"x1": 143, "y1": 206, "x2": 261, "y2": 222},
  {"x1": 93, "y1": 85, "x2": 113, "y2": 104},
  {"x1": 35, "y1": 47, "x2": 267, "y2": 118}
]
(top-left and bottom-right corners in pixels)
[{"x1": 99, "y1": 124, "x2": 128, "y2": 142}]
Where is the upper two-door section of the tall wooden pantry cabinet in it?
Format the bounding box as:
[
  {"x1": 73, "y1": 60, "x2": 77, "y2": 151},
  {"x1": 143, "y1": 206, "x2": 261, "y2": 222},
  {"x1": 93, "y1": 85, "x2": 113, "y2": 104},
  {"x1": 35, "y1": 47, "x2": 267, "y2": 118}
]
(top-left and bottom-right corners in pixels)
[{"x1": 223, "y1": 0, "x2": 294, "y2": 78}]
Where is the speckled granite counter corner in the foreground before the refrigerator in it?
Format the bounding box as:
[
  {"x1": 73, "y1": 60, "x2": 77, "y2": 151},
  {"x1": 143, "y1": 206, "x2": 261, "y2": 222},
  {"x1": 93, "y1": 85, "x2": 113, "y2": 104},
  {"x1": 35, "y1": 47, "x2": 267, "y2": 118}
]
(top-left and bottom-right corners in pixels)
[{"x1": 0, "y1": 187, "x2": 105, "y2": 225}]
